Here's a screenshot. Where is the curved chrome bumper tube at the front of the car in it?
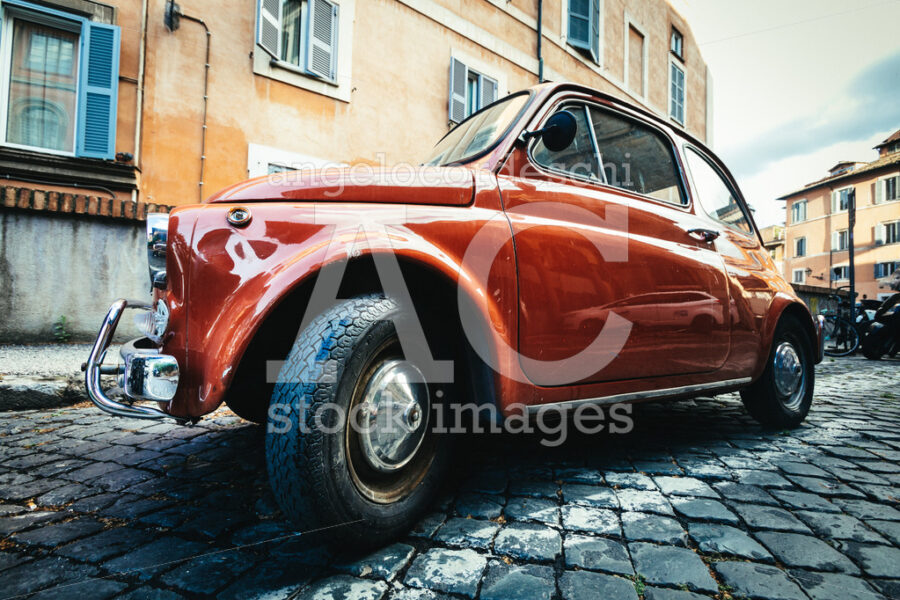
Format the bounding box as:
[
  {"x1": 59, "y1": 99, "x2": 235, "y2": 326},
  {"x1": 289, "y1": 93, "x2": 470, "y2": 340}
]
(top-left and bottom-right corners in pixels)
[{"x1": 84, "y1": 298, "x2": 180, "y2": 421}]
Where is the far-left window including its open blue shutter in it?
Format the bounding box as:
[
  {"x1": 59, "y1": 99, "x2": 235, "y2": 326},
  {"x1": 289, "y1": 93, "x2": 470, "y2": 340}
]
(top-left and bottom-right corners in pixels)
[{"x1": 0, "y1": 2, "x2": 119, "y2": 159}]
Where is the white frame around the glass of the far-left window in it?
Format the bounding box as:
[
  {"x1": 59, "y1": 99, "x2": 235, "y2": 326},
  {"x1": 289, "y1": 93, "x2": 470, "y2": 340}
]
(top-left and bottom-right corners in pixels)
[{"x1": 0, "y1": 2, "x2": 87, "y2": 157}]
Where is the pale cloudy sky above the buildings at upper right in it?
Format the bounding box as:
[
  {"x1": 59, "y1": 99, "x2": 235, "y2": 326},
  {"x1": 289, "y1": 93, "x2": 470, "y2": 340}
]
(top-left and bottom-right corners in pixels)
[{"x1": 671, "y1": 0, "x2": 900, "y2": 227}]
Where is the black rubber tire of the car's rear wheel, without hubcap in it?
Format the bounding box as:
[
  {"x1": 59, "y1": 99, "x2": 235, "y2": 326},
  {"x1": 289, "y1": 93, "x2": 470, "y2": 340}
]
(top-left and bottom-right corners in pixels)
[{"x1": 741, "y1": 315, "x2": 815, "y2": 429}]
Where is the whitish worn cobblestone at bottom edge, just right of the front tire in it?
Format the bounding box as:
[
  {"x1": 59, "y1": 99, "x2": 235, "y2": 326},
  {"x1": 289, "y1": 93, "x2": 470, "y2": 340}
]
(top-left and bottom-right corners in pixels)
[{"x1": 403, "y1": 548, "x2": 487, "y2": 598}]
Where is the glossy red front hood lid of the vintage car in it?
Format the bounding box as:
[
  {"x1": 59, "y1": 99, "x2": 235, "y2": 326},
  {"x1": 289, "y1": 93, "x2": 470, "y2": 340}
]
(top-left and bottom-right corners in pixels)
[{"x1": 207, "y1": 165, "x2": 475, "y2": 206}]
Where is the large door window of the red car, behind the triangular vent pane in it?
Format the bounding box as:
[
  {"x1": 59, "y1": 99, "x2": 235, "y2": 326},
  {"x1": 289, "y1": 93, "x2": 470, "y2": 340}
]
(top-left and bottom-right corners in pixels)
[{"x1": 590, "y1": 108, "x2": 685, "y2": 204}]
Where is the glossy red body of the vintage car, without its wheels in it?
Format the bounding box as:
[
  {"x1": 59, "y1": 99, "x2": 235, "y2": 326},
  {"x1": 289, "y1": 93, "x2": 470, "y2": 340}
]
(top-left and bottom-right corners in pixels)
[{"x1": 87, "y1": 84, "x2": 821, "y2": 540}]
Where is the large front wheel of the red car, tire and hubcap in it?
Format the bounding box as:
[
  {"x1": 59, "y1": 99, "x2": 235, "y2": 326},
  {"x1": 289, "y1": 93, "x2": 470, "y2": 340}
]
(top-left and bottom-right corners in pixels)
[{"x1": 266, "y1": 296, "x2": 450, "y2": 546}]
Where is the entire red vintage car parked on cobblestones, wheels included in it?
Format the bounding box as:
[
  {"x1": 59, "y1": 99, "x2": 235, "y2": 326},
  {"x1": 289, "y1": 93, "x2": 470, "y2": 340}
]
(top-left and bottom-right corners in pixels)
[{"x1": 86, "y1": 84, "x2": 822, "y2": 543}]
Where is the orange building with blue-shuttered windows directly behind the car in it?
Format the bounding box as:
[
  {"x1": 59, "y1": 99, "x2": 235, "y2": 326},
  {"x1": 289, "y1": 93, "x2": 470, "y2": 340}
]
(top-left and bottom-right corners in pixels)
[{"x1": 0, "y1": 0, "x2": 711, "y2": 341}]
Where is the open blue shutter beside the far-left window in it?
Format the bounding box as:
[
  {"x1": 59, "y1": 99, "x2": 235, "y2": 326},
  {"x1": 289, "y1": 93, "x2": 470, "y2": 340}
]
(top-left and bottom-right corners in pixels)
[{"x1": 77, "y1": 22, "x2": 119, "y2": 159}]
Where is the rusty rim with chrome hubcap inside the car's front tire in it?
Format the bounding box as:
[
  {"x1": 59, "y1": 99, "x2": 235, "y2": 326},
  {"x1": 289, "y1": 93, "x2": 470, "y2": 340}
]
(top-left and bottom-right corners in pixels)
[{"x1": 344, "y1": 342, "x2": 436, "y2": 504}]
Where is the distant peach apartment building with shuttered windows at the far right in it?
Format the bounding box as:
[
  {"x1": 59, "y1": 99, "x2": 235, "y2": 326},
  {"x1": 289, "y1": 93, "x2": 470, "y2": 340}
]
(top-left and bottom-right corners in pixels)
[{"x1": 780, "y1": 130, "x2": 900, "y2": 298}]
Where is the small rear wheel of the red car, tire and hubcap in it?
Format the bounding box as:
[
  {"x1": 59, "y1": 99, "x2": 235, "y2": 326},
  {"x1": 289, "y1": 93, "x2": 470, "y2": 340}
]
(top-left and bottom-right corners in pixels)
[{"x1": 741, "y1": 315, "x2": 815, "y2": 428}]
